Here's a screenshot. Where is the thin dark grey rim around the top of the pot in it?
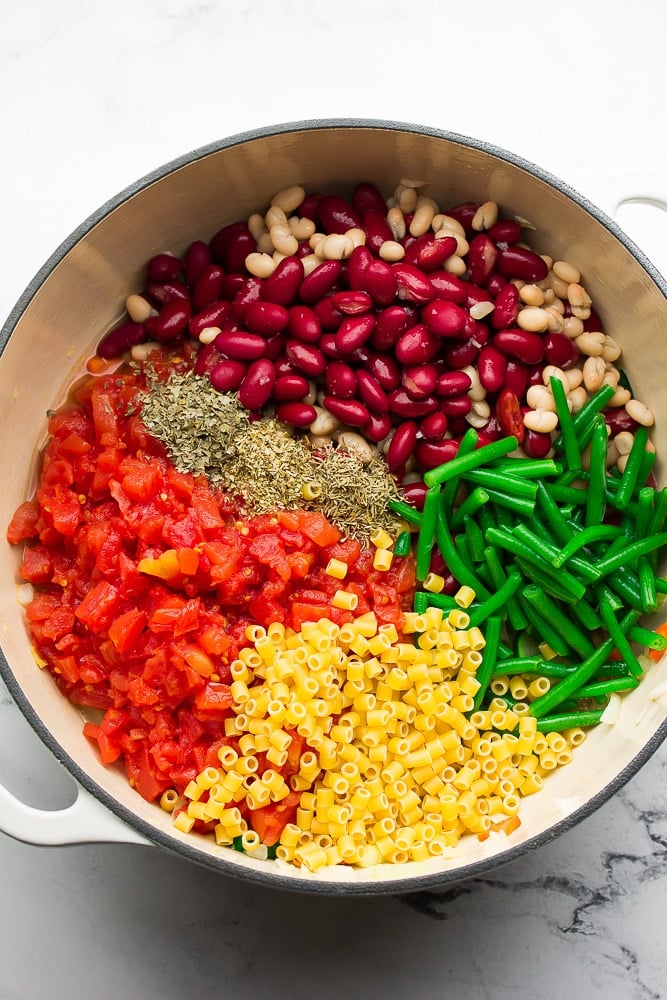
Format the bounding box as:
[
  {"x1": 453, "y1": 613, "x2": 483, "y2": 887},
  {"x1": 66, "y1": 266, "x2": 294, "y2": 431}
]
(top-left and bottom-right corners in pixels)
[{"x1": 0, "y1": 118, "x2": 667, "y2": 896}]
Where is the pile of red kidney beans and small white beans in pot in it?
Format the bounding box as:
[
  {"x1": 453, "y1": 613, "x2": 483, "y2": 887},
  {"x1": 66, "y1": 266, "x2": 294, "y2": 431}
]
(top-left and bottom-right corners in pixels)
[{"x1": 98, "y1": 180, "x2": 653, "y2": 506}]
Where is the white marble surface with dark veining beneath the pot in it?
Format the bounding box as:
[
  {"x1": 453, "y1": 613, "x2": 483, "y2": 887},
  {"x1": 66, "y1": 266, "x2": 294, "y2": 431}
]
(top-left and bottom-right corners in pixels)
[{"x1": 0, "y1": 0, "x2": 667, "y2": 1000}]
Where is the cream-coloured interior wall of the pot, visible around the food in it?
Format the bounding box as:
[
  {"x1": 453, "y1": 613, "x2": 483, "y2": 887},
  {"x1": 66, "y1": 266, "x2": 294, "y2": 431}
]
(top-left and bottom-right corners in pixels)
[{"x1": 0, "y1": 127, "x2": 667, "y2": 885}]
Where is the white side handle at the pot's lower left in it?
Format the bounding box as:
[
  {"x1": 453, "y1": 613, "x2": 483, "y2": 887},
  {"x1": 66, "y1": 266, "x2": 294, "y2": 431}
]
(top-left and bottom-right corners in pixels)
[{"x1": 0, "y1": 785, "x2": 152, "y2": 847}]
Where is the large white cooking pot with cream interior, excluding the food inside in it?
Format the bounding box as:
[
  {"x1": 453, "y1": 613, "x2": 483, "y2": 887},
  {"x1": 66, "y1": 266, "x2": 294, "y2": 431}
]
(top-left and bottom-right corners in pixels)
[{"x1": 0, "y1": 120, "x2": 667, "y2": 894}]
